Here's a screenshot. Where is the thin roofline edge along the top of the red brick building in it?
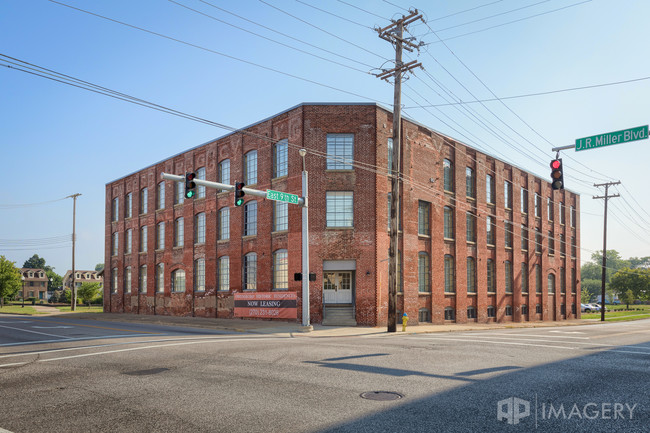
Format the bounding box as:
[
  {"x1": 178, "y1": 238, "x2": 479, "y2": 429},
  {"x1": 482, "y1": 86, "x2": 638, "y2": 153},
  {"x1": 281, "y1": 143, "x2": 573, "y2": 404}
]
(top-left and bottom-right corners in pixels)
[{"x1": 106, "y1": 102, "x2": 580, "y2": 196}]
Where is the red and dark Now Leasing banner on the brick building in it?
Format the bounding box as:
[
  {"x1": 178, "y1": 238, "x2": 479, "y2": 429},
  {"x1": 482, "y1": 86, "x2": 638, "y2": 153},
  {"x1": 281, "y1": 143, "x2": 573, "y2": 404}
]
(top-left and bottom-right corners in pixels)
[{"x1": 235, "y1": 292, "x2": 298, "y2": 319}]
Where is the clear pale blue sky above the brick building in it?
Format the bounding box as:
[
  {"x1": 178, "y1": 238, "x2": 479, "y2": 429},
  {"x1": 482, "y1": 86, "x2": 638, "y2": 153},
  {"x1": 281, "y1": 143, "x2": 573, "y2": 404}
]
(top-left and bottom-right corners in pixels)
[{"x1": 0, "y1": 0, "x2": 650, "y2": 274}]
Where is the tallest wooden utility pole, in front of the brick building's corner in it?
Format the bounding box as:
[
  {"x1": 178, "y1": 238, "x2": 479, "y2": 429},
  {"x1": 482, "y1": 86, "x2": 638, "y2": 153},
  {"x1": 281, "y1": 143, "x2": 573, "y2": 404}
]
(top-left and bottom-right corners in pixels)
[{"x1": 375, "y1": 9, "x2": 422, "y2": 332}]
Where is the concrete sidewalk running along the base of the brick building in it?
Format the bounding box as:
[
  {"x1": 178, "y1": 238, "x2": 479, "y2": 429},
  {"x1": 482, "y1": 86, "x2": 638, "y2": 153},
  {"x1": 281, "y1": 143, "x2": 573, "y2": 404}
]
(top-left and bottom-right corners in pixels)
[{"x1": 29, "y1": 307, "x2": 601, "y2": 337}]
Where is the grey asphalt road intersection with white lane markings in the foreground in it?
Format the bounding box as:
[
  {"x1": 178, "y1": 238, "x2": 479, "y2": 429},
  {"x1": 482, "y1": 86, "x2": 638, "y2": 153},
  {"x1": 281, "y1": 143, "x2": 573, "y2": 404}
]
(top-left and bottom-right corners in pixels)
[{"x1": 0, "y1": 316, "x2": 650, "y2": 432}]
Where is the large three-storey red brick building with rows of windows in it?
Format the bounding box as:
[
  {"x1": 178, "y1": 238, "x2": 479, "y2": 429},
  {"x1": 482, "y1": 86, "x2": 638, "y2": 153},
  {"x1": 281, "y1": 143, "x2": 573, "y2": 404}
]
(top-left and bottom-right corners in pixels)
[{"x1": 104, "y1": 103, "x2": 580, "y2": 326}]
